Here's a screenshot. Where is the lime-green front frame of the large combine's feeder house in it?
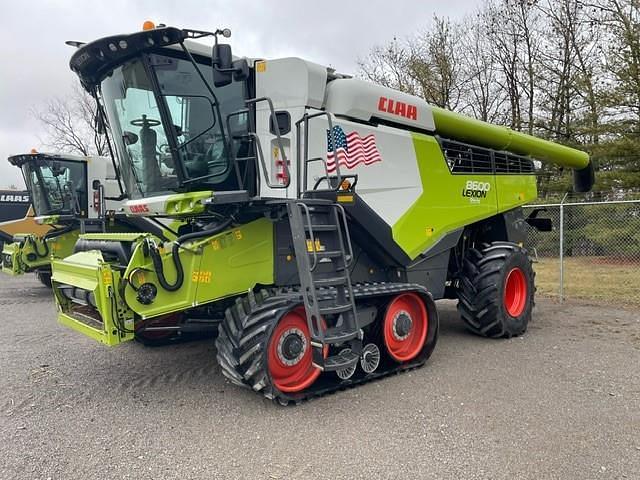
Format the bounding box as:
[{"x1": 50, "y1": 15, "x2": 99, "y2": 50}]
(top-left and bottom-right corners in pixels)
[{"x1": 51, "y1": 250, "x2": 134, "y2": 345}]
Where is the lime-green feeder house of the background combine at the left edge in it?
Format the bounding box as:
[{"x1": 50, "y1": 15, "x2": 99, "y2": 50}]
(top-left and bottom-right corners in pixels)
[{"x1": 2, "y1": 229, "x2": 80, "y2": 275}]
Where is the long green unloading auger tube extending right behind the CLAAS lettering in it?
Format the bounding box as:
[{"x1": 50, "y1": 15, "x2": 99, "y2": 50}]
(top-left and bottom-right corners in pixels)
[{"x1": 431, "y1": 106, "x2": 589, "y2": 169}]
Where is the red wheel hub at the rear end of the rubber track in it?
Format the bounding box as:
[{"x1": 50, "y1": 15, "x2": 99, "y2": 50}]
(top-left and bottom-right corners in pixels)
[{"x1": 383, "y1": 293, "x2": 429, "y2": 362}]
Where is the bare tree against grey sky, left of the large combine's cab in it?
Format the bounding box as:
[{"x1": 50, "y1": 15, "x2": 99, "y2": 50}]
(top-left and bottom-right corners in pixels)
[{"x1": 33, "y1": 85, "x2": 108, "y2": 155}]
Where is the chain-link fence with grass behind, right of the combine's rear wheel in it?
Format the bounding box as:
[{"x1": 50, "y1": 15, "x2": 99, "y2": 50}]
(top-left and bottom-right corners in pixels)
[{"x1": 525, "y1": 192, "x2": 640, "y2": 306}]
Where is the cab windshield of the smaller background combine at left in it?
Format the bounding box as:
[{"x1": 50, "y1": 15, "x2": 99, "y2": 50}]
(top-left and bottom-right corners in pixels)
[{"x1": 22, "y1": 159, "x2": 87, "y2": 216}]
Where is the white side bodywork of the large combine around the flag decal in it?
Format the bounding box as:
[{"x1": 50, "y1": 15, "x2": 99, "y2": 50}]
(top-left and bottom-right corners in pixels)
[{"x1": 250, "y1": 58, "x2": 424, "y2": 226}]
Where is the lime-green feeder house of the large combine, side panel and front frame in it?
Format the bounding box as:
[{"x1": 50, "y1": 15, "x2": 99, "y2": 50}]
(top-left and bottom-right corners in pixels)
[{"x1": 52, "y1": 218, "x2": 274, "y2": 345}]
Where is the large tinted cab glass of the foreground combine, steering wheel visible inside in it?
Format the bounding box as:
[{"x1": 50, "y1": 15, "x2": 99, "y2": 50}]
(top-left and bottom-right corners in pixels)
[{"x1": 101, "y1": 50, "x2": 246, "y2": 198}]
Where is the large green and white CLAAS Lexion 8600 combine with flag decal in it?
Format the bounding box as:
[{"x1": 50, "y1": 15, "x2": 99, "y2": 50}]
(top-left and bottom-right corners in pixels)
[{"x1": 52, "y1": 24, "x2": 593, "y2": 403}]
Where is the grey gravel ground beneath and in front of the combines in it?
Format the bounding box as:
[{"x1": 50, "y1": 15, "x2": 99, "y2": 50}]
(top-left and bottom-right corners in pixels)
[{"x1": 0, "y1": 276, "x2": 640, "y2": 480}]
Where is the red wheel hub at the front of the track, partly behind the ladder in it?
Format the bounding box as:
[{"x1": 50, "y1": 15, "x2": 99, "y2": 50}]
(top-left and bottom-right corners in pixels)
[{"x1": 267, "y1": 307, "x2": 327, "y2": 393}]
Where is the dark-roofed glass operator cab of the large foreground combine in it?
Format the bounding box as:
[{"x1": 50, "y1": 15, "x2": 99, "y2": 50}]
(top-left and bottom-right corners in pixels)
[{"x1": 71, "y1": 27, "x2": 257, "y2": 199}]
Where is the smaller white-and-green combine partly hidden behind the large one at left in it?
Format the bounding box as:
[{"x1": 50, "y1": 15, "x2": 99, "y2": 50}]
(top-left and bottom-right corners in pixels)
[{"x1": 2, "y1": 151, "x2": 201, "y2": 343}]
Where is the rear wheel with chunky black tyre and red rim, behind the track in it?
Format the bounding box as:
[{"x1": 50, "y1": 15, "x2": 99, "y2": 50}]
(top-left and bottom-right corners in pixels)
[{"x1": 458, "y1": 242, "x2": 535, "y2": 338}]
